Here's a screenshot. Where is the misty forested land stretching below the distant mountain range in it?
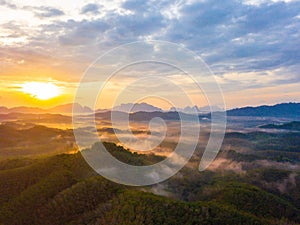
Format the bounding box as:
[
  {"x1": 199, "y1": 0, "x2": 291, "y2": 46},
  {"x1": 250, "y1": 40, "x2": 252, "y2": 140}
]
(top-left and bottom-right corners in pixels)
[{"x1": 0, "y1": 103, "x2": 300, "y2": 225}]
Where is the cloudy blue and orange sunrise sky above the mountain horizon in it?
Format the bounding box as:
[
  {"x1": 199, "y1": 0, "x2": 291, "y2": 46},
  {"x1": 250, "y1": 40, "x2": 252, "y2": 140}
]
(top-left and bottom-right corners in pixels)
[{"x1": 0, "y1": 0, "x2": 300, "y2": 108}]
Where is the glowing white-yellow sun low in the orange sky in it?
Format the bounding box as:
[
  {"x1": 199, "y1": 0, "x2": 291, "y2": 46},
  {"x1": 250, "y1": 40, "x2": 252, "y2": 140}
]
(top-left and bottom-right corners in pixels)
[{"x1": 21, "y1": 81, "x2": 61, "y2": 100}]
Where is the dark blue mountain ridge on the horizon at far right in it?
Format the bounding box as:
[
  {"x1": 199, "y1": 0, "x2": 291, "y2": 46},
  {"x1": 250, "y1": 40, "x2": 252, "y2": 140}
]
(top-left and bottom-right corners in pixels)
[{"x1": 227, "y1": 103, "x2": 300, "y2": 118}]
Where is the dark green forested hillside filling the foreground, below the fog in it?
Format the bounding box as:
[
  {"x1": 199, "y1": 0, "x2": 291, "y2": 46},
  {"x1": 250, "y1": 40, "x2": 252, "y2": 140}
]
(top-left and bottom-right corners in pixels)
[{"x1": 0, "y1": 143, "x2": 299, "y2": 225}]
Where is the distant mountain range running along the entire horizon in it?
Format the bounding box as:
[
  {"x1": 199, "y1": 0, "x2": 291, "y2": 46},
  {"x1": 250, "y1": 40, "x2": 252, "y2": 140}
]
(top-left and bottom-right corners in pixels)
[{"x1": 0, "y1": 103, "x2": 300, "y2": 120}]
